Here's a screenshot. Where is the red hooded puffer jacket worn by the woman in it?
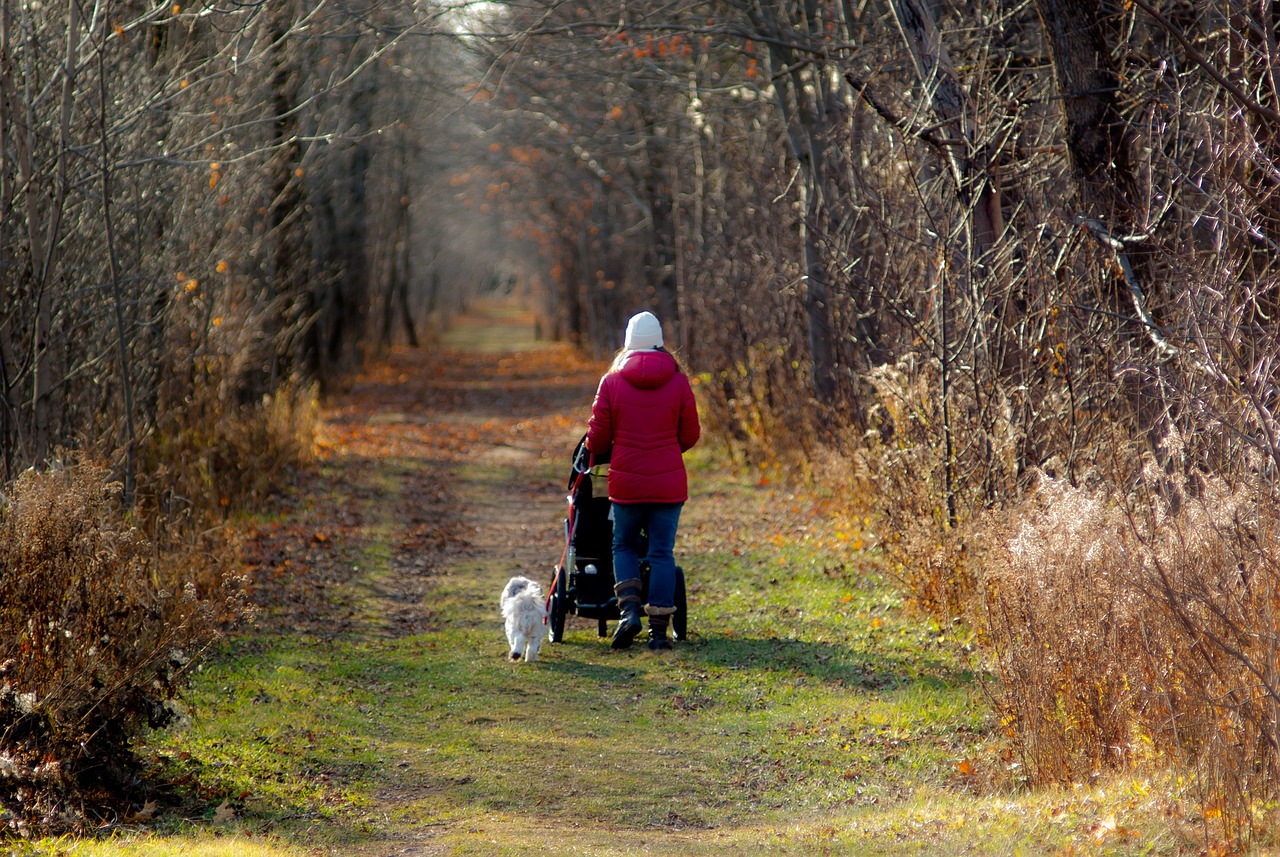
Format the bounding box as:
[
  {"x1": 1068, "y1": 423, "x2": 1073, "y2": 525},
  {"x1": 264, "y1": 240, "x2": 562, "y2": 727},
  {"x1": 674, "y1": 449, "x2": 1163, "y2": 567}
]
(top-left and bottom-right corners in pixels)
[{"x1": 586, "y1": 349, "x2": 701, "y2": 503}]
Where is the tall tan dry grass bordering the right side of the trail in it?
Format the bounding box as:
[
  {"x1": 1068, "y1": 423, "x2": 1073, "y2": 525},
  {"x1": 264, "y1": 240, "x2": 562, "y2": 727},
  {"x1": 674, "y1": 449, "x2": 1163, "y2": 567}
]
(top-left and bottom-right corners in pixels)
[{"x1": 858, "y1": 350, "x2": 1280, "y2": 847}]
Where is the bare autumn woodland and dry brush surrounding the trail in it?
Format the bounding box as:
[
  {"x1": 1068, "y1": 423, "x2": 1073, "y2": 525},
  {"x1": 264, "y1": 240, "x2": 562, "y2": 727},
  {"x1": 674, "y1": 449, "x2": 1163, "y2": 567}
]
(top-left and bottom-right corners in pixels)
[{"x1": 0, "y1": 0, "x2": 1280, "y2": 842}]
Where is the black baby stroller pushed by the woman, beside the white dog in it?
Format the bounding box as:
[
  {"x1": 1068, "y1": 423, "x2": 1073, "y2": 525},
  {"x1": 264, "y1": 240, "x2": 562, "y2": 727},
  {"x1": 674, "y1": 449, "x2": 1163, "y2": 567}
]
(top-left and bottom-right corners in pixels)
[{"x1": 549, "y1": 436, "x2": 689, "y2": 642}]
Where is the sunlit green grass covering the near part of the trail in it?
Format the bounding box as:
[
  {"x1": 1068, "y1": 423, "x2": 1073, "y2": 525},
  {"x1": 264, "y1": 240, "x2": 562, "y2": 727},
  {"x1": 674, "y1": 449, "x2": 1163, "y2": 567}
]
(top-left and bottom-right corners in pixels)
[{"x1": 18, "y1": 305, "x2": 1196, "y2": 857}]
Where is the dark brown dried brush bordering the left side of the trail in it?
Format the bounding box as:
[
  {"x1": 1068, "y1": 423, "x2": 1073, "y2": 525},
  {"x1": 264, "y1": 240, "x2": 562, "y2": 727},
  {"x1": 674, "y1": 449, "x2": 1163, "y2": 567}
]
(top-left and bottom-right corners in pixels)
[{"x1": 0, "y1": 301, "x2": 316, "y2": 834}]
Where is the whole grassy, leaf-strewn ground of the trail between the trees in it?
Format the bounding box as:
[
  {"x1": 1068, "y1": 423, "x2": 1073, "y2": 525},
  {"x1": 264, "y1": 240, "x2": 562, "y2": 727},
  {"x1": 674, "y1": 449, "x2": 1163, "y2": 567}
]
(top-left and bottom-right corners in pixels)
[{"x1": 35, "y1": 307, "x2": 1198, "y2": 857}]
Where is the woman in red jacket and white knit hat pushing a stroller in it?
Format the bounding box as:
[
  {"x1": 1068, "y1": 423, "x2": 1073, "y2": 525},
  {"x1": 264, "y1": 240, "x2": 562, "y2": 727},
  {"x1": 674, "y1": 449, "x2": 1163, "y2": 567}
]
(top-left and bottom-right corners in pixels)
[{"x1": 586, "y1": 312, "x2": 701, "y2": 651}]
